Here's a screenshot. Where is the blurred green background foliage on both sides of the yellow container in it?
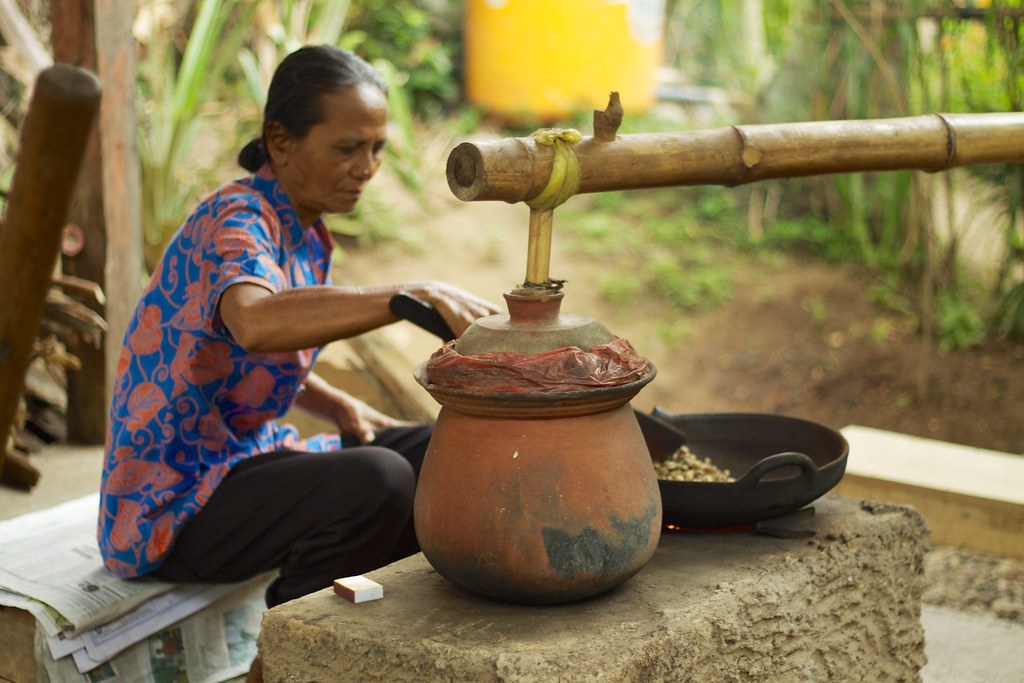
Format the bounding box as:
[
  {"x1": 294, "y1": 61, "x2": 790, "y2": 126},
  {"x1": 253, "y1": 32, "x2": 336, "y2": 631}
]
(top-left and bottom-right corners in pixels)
[{"x1": 9, "y1": 0, "x2": 1024, "y2": 348}]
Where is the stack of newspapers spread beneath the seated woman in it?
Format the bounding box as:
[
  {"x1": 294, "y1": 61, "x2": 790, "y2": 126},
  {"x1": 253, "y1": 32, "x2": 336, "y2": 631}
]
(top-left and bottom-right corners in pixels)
[{"x1": 0, "y1": 494, "x2": 271, "y2": 683}]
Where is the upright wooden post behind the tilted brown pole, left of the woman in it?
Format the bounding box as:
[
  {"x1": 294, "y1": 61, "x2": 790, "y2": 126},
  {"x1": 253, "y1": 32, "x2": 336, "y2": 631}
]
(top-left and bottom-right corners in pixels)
[{"x1": 51, "y1": 0, "x2": 142, "y2": 443}]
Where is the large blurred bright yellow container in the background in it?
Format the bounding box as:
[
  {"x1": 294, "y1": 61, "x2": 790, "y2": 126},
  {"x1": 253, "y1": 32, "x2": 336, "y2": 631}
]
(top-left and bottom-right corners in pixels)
[{"x1": 465, "y1": 0, "x2": 665, "y2": 121}]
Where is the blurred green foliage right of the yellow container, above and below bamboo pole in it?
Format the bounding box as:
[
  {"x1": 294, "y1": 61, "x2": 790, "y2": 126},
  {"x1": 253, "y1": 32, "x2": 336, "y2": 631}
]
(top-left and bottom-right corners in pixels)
[{"x1": 569, "y1": 0, "x2": 1024, "y2": 348}]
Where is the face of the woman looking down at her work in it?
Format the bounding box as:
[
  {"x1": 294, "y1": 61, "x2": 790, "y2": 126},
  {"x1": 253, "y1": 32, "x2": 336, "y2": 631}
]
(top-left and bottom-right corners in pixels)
[{"x1": 267, "y1": 83, "x2": 387, "y2": 226}]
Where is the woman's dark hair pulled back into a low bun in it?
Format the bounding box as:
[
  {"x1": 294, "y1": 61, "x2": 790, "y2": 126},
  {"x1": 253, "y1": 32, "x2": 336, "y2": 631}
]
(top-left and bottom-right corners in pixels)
[{"x1": 239, "y1": 45, "x2": 387, "y2": 173}]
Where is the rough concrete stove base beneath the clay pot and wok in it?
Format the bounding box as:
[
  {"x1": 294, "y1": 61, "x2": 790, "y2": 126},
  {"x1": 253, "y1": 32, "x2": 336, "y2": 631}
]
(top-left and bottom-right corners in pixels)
[{"x1": 259, "y1": 496, "x2": 928, "y2": 683}]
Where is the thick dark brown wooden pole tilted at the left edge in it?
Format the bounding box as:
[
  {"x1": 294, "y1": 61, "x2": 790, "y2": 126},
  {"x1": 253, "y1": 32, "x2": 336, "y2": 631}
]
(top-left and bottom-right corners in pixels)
[{"x1": 0, "y1": 65, "x2": 100, "y2": 481}]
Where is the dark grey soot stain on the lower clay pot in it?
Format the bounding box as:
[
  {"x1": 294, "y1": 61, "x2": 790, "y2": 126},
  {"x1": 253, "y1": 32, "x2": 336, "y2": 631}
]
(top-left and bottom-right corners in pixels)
[{"x1": 541, "y1": 505, "x2": 657, "y2": 578}]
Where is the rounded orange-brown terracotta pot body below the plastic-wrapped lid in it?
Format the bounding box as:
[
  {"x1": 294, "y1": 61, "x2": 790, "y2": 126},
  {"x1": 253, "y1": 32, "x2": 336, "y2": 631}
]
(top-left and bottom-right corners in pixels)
[{"x1": 415, "y1": 382, "x2": 662, "y2": 604}]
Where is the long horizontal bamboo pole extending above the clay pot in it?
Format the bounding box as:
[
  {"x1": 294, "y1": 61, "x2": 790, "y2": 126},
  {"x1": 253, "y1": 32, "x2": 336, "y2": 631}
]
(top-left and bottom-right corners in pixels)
[{"x1": 447, "y1": 113, "x2": 1024, "y2": 203}]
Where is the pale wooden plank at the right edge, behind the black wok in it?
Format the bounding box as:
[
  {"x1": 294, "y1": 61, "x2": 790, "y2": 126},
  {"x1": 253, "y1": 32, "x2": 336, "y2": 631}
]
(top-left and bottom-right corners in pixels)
[{"x1": 835, "y1": 426, "x2": 1024, "y2": 559}]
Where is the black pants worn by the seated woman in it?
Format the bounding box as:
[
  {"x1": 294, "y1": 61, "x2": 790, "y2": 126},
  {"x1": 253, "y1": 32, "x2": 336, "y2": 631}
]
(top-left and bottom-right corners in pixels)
[{"x1": 153, "y1": 425, "x2": 433, "y2": 607}]
